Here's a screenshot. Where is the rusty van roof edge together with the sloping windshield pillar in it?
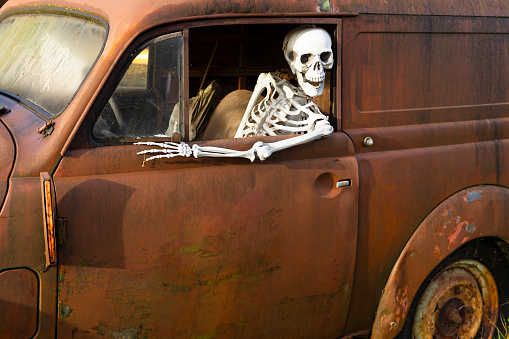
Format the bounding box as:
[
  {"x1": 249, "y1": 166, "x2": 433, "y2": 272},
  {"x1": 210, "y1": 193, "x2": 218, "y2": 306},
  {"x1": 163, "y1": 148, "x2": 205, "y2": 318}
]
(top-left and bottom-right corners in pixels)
[{"x1": 0, "y1": 0, "x2": 509, "y2": 167}]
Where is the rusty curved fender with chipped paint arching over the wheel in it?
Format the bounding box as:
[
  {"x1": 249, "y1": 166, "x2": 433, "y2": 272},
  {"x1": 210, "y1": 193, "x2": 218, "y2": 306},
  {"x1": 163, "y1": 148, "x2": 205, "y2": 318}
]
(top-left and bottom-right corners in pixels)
[{"x1": 372, "y1": 186, "x2": 509, "y2": 338}]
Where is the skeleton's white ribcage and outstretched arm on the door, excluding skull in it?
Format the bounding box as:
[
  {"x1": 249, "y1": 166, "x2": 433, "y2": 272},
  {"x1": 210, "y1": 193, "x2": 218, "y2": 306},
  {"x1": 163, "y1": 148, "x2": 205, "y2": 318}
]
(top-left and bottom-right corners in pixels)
[{"x1": 136, "y1": 73, "x2": 333, "y2": 162}]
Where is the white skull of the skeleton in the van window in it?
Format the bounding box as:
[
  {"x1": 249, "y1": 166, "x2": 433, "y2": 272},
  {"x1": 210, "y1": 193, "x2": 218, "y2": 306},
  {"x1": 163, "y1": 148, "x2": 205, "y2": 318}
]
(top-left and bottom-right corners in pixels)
[{"x1": 283, "y1": 26, "x2": 334, "y2": 97}]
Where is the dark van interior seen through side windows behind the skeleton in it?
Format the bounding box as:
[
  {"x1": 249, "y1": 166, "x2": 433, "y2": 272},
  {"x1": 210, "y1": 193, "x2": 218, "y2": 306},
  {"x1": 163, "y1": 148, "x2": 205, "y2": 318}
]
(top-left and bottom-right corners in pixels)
[{"x1": 92, "y1": 24, "x2": 337, "y2": 144}]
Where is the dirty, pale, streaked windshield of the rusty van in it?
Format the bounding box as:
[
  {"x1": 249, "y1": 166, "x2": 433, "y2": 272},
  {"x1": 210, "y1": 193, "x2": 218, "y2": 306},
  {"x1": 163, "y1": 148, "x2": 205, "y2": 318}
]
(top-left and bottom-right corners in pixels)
[{"x1": 0, "y1": 12, "x2": 107, "y2": 118}]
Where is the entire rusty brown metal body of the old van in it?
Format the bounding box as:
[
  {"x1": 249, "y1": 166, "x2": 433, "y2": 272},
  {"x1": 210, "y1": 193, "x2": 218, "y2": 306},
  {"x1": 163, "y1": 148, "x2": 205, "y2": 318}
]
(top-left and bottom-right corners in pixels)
[{"x1": 0, "y1": 0, "x2": 509, "y2": 338}]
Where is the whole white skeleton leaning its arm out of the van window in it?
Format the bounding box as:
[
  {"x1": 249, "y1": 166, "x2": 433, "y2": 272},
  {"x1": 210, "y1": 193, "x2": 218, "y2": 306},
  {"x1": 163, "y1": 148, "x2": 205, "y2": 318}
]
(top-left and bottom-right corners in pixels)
[{"x1": 136, "y1": 26, "x2": 334, "y2": 162}]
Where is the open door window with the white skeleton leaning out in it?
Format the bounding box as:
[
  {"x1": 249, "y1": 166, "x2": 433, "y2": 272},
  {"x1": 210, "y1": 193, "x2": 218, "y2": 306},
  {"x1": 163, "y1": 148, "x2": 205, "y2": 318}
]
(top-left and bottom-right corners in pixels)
[{"x1": 133, "y1": 25, "x2": 334, "y2": 161}]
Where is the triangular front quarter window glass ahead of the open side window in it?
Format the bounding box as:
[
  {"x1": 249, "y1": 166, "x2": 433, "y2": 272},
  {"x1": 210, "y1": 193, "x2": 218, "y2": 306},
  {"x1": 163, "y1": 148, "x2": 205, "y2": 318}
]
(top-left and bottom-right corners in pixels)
[{"x1": 93, "y1": 33, "x2": 184, "y2": 141}]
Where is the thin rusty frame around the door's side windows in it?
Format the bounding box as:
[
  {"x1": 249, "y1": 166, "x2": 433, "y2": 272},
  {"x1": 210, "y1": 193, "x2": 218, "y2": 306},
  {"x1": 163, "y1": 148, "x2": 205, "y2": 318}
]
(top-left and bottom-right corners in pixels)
[{"x1": 70, "y1": 15, "x2": 342, "y2": 148}]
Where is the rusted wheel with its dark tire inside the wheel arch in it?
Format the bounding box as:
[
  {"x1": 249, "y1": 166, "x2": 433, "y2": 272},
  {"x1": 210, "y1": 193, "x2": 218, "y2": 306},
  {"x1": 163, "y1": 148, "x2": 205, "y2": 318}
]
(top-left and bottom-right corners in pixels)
[{"x1": 397, "y1": 239, "x2": 509, "y2": 339}]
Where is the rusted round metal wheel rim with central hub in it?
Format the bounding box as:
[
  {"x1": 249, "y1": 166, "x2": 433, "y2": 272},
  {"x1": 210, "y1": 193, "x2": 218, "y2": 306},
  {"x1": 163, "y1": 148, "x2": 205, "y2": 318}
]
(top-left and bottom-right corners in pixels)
[{"x1": 412, "y1": 259, "x2": 498, "y2": 339}]
